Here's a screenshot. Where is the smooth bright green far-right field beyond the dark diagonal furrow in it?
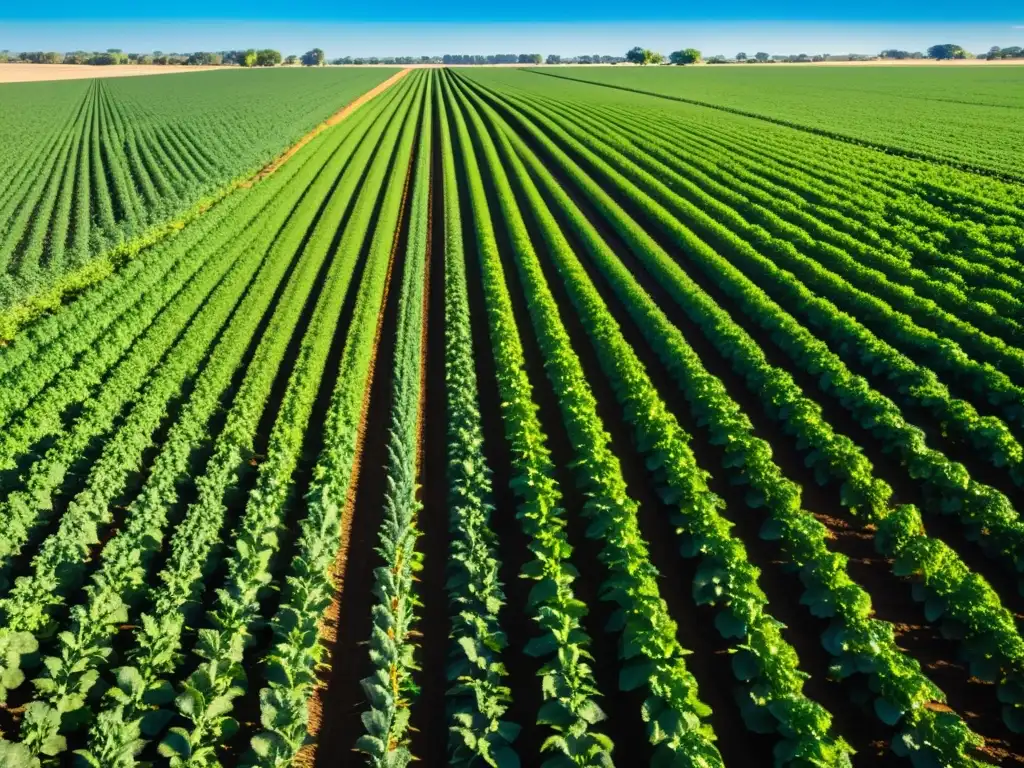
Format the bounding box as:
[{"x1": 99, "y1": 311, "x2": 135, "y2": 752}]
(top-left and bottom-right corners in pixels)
[{"x1": 543, "y1": 65, "x2": 1024, "y2": 181}]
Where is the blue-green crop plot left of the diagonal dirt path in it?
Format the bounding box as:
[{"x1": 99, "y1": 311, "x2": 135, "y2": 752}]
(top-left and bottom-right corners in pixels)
[{"x1": 0, "y1": 69, "x2": 394, "y2": 310}]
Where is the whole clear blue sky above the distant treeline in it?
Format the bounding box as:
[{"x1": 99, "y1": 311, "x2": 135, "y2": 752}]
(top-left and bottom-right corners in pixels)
[{"x1": 0, "y1": 0, "x2": 1024, "y2": 56}]
